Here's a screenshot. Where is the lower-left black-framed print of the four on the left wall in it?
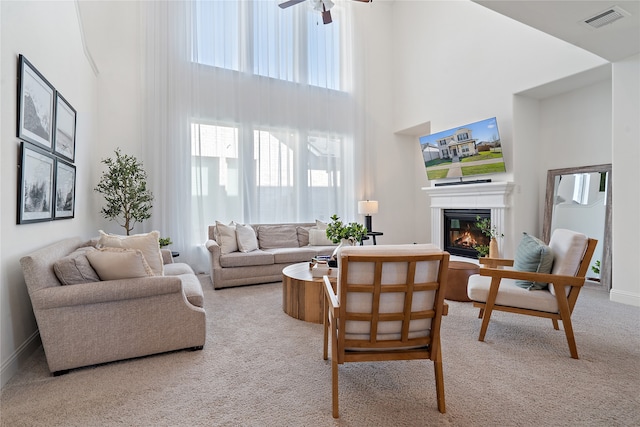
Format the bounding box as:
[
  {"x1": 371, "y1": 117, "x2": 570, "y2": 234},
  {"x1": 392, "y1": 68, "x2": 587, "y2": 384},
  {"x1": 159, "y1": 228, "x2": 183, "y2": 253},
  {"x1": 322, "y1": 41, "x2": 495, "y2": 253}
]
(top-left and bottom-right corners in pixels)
[{"x1": 18, "y1": 141, "x2": 56, "y2": 224}]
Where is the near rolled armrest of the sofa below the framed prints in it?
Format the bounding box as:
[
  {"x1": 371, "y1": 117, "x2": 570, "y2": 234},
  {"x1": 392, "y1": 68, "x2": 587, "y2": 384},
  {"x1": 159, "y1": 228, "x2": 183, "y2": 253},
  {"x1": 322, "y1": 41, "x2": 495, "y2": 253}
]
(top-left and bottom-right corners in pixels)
[{"x1": 31, "y1": 276, "x2": 182, "y2": 309}]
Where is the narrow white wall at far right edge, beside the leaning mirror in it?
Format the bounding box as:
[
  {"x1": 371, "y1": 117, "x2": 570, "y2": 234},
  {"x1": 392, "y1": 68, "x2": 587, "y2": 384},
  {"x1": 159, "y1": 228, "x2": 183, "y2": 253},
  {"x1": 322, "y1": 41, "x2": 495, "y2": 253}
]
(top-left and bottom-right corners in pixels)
[{"x1": 610, "y1": 55, "x2": 640, "y2": 306}]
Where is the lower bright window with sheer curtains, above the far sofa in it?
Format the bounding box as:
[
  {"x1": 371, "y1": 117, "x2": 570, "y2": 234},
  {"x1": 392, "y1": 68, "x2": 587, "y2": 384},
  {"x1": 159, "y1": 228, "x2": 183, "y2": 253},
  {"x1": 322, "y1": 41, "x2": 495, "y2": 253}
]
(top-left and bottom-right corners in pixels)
[{"x1": 191, "y1": 123, "x2": 345, "y2": 222}]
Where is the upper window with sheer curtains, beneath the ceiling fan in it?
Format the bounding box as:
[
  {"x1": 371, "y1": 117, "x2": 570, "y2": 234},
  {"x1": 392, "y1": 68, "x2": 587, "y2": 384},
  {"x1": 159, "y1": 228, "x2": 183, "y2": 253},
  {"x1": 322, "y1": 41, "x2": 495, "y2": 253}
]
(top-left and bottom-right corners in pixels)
[{"x1": 193, "y1": 0, "x2": 341, "y2": 90}]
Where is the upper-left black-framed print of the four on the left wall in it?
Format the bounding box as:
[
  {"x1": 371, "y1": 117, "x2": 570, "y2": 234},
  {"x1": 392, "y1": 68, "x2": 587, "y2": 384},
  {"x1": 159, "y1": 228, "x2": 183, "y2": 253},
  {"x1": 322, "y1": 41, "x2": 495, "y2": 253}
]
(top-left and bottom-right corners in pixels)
[{"x1": 17, "y1": 55, "x2": 55, "y2": 151}]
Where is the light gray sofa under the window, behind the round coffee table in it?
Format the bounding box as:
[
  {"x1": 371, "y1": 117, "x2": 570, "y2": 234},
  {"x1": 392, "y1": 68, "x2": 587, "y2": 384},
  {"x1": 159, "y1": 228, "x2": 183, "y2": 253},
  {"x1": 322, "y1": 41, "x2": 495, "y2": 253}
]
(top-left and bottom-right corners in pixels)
[{"x1": 205, "y1": 223, "x2": 337, "y2": 289}]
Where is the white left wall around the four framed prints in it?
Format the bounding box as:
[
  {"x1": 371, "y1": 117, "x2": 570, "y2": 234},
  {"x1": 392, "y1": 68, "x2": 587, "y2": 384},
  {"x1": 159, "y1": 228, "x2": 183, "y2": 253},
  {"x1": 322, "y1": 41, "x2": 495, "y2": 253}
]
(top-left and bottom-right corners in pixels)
[{"x1": 0, "y1": 1, "x2": 98, "y2": 384}]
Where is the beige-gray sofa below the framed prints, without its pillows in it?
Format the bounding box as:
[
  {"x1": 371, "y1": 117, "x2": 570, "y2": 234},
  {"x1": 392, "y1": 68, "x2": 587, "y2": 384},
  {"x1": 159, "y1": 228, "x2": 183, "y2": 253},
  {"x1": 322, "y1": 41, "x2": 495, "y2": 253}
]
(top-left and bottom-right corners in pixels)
[{"x1": 20, "y1": 237, "x2": 206, "y2": 375}]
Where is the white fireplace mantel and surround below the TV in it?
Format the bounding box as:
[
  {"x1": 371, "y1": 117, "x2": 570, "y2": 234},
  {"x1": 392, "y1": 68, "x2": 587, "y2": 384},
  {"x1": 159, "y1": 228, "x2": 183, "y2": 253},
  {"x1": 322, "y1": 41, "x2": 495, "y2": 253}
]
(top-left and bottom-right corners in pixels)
[{"x1": 422, "y1": 181, "x2": 514, "y2": 252}]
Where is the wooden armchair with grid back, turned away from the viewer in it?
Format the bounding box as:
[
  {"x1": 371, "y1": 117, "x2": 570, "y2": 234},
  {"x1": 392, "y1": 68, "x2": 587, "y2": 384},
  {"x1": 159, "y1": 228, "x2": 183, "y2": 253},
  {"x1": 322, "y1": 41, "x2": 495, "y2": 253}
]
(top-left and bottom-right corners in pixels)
[{"x1": 324, "y1": 245, "x2": 449, "y2": 418}]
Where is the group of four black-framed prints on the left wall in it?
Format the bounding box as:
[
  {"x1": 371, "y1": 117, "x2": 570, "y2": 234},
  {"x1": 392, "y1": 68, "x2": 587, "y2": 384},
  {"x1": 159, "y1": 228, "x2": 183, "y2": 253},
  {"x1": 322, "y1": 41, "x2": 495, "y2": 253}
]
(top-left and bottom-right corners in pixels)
[{"x1": 17, "y1": 55, "x2": 77, "y2": 224}]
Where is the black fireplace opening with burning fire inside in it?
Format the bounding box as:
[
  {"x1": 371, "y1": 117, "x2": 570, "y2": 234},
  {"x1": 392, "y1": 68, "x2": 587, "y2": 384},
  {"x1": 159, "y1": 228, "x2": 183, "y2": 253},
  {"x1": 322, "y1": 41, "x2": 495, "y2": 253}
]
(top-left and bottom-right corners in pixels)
[{"x1": 443, "y1": 209, "x2": 491, "y2": 258}]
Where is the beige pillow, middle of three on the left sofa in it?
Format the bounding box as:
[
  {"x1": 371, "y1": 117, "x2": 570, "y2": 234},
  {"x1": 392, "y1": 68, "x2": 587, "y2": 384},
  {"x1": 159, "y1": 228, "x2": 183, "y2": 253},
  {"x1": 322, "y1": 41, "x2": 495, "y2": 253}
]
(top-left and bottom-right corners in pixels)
[{"x1": 86, "y1": 247, "x2": 154, "y2": 280}]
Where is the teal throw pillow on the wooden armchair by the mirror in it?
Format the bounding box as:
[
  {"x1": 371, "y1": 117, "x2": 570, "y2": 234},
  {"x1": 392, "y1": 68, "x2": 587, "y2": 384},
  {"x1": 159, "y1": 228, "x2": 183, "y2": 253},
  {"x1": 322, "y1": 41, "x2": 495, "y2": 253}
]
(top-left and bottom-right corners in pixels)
[{"x1": 513, "y1": 233, "x2": 553, "y2": 290}]
